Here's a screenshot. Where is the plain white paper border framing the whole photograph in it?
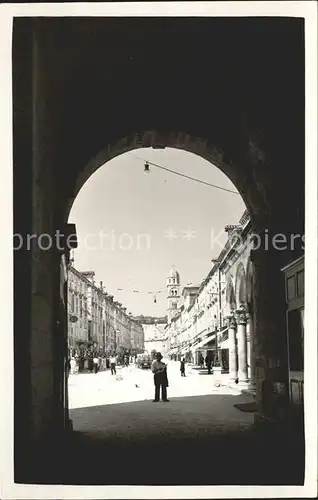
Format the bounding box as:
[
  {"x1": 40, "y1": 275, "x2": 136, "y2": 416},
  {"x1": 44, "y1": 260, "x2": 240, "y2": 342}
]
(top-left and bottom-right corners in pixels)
[{"x1": 0, "y1": 1, "x2": 318, "y2": 500}]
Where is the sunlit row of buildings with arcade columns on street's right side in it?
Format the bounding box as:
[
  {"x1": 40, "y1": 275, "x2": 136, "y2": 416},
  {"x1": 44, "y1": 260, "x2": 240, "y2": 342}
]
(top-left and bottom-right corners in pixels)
[{"x1": 166, "y1": 211, "x2": 255, "y2": 390}]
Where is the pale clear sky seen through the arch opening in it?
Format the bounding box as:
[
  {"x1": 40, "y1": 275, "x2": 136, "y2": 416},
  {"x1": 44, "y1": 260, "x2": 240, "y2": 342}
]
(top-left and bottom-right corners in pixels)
[{"x1": 69, "y1": 148, "x2": 245, "y2": 315}]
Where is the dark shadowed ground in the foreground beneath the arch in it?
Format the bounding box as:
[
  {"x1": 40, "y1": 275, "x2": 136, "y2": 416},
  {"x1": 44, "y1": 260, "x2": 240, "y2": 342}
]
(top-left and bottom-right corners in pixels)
[{"x1": 24, "y1": 395, "x2": 304, "y2": 485}]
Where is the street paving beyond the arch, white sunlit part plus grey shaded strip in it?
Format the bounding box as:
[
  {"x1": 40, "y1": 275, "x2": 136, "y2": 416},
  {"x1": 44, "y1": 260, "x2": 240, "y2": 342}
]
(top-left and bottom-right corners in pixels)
[{"x1": 70, "y1": 363, "x2": 253, "y2": 439}]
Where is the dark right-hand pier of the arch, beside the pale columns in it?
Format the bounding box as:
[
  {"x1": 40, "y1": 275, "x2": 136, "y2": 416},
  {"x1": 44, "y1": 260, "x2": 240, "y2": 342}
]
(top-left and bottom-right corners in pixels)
[{"x1": 251, "y1": 242, "x2": 288, "y2": 422}]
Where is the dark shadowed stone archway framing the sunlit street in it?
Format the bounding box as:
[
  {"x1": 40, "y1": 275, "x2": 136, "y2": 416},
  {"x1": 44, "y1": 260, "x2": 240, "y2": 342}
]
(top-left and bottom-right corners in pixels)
[{"x1": 12, "y1": 17, "x2": 304, "y2": 471}]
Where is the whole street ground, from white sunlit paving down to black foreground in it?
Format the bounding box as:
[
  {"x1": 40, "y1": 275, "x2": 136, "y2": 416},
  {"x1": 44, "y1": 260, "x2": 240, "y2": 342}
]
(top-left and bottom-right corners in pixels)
[{"x1": 63, "y1": 362, "x2": 302, "y2": 485}]
